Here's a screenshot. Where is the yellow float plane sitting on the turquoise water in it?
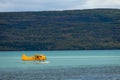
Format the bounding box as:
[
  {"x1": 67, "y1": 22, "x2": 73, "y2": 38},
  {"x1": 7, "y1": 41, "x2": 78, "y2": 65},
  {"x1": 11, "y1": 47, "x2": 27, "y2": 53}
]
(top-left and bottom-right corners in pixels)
[{"x1": 22, "y1": 54, "x2": 47, "y2": 61}]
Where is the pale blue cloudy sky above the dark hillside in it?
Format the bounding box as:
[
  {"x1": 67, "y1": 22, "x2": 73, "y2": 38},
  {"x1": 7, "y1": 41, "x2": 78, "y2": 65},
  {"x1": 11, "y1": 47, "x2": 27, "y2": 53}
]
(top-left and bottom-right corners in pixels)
[{"x1": 0, "y1": 0, "x2": 120, "y2": 12}]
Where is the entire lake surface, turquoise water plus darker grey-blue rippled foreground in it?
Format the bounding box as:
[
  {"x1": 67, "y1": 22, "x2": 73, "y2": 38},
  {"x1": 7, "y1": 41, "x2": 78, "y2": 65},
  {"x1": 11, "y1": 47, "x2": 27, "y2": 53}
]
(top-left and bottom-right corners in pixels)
[{"x1": 0, "y1": 50, "x2": 120, "y2": 80}]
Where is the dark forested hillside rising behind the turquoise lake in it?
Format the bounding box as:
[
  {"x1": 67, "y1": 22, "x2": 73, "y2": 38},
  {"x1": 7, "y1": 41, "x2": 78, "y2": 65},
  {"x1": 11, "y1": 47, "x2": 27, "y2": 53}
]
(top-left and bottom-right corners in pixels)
[{"x1": 0, "y1": 9, "x2": 120, "y2": 51}]
